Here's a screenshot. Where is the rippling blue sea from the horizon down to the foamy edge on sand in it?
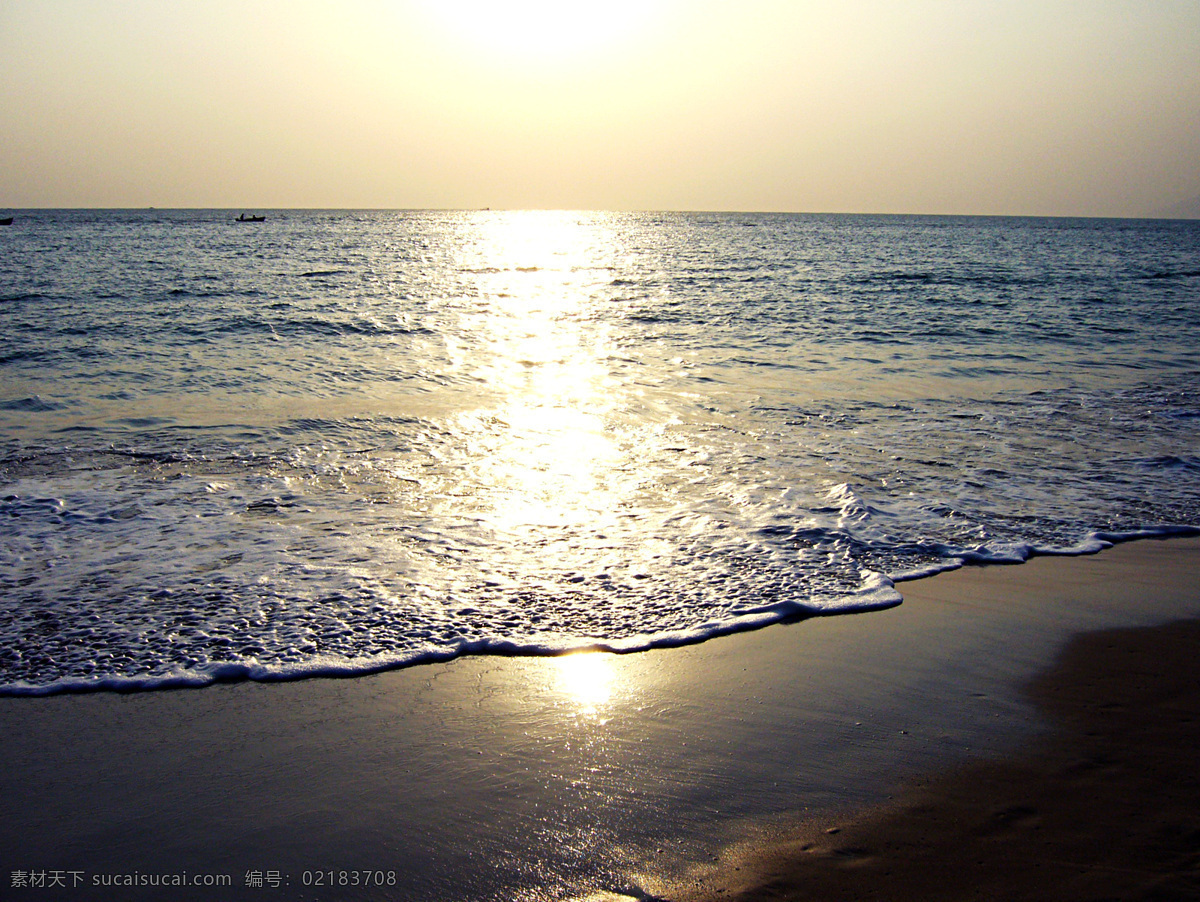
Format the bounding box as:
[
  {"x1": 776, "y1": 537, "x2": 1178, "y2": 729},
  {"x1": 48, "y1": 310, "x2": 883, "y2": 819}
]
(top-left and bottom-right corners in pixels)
[{"x1": 0, "y1": 210, "x2": 1200, "y2": 693}]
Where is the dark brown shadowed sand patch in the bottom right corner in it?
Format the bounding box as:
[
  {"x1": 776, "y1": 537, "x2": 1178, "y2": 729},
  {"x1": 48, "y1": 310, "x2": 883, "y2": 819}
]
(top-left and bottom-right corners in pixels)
[{"x1": 668, "y1": 539, "x2": 1200, "y2": 902}]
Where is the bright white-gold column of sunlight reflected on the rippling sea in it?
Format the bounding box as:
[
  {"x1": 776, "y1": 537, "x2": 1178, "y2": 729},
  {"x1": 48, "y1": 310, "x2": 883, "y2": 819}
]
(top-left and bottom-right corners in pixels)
[{"x1": 444, "y1": 211, "x2": 648, "y2": 569}]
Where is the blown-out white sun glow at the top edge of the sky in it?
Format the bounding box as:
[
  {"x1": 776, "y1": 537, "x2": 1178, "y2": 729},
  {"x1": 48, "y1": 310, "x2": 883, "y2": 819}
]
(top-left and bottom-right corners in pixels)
[{"x1": 428, "y1": 0, "x2": 655, "y2": 60}]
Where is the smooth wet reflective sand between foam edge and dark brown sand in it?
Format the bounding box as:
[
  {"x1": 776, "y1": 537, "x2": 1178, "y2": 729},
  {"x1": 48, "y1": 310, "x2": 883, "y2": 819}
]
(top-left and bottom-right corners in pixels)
[{"x1": 0, "y1": 537, "x2": 1200, "y2": 902}]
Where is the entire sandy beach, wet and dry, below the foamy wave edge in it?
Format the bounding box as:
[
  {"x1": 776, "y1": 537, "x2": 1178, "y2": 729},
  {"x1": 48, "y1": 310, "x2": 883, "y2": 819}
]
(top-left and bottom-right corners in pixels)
[{"x1": 0, "y1": 539, "x2": 1200, "y2": 900}]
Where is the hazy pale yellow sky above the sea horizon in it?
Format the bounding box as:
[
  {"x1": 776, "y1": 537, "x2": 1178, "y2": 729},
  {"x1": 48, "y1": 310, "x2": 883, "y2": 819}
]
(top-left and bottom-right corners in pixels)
[{"x1": 0, "y1": 0, "x2": 1200, "y2": 217}]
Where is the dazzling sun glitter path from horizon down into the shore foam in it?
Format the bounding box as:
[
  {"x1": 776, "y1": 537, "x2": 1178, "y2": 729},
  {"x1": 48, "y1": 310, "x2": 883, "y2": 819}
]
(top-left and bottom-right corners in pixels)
[{"x1": 429, "y1": 211, "x2": 676, "y2": 618}]
